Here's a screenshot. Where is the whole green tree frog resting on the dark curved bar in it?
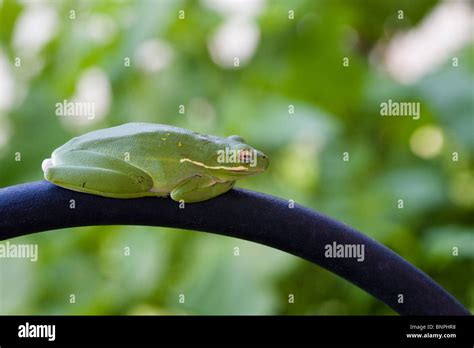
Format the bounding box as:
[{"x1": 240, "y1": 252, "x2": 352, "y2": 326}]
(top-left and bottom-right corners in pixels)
[{"x1": 42, "y1": 123, "x2": 269, "y2": 203}]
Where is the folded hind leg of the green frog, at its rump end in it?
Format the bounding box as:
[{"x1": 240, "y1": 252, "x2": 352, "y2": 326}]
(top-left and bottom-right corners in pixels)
[{"x1": 44, "y1": 151, "x2": 153, "y2": 198}]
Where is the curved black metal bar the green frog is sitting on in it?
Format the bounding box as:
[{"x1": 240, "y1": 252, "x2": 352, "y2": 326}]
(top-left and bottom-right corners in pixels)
[{"x1": 0, "y1": 181, "x2": 470, "y2": 315}]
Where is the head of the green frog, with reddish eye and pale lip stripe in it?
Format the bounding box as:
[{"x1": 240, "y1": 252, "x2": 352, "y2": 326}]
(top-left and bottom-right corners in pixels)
[{"x1": 202, "y1": 135, "x2": 270, "y2": 181}]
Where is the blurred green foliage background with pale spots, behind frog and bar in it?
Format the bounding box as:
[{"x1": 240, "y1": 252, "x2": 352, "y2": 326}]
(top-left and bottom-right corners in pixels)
[{"x1": 0, "y1": 0, "x2": 474, "y2": 315}]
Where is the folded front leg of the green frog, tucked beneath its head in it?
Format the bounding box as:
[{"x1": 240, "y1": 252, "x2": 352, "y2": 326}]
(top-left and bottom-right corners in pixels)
[{"x1": 171, "y1": 175, "x2": 235, "y2": 203}]
